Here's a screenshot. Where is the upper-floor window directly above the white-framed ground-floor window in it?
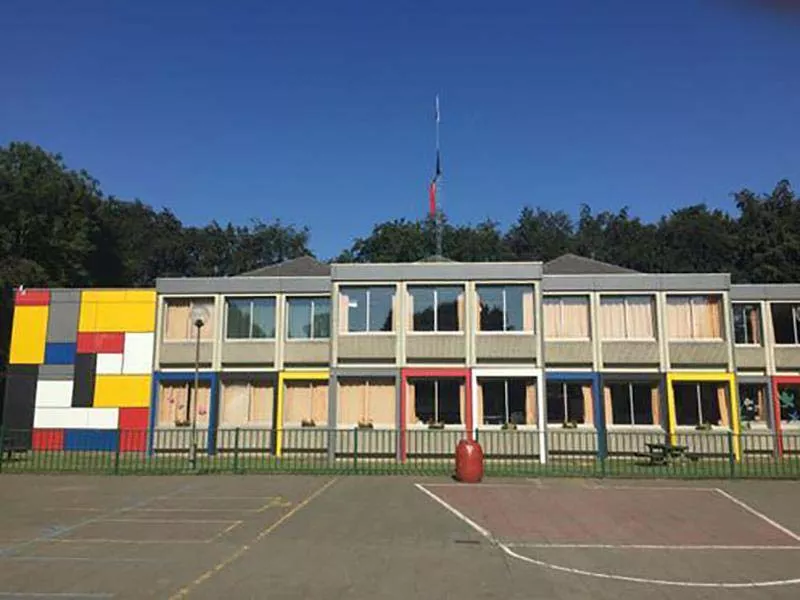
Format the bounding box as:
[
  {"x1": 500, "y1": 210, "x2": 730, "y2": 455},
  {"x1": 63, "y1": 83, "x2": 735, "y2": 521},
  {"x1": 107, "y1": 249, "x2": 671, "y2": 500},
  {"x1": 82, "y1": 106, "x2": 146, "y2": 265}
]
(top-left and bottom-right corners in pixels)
[{"x1": 477, "y1": 285, "x2": 533, "y2": 332}]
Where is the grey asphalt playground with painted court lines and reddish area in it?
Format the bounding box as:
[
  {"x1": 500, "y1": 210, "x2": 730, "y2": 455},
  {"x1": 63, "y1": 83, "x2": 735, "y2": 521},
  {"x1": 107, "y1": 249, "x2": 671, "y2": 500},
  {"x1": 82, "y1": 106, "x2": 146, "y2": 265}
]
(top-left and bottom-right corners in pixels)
[{"x1": 0, "y1": 475, "x2": 800, "y2": 600}]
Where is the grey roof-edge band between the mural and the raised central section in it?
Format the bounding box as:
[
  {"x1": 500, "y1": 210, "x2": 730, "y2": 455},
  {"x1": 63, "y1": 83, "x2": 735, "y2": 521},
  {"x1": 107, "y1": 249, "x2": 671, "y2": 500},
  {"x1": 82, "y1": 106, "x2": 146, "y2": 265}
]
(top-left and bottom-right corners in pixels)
[{"x1": 156, "y1": 277, "x2": 331, "y2": 295}]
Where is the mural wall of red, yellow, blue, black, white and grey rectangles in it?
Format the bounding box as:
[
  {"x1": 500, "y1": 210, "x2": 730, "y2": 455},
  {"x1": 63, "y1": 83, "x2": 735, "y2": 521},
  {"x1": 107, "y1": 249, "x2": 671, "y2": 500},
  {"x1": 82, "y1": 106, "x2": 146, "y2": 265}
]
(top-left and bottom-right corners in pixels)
[{"x1": 3, "y1": 290, "x2": 156, "y2": 451}]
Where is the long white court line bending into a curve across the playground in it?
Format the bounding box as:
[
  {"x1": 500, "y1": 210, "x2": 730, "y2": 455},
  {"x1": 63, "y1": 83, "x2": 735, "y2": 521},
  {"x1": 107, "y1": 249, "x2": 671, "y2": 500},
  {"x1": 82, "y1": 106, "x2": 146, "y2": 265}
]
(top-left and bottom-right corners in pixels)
[{"x1": 414, "y1": 483, "x2": 800, "y2": 589}]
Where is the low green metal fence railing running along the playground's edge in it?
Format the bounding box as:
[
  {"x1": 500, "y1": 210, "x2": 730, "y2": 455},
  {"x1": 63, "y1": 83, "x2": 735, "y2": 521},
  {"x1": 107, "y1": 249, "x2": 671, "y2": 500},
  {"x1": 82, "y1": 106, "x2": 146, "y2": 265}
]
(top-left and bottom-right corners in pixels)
[{"x1": 0, "y1": 428, "x2": 800, "y2": 478}]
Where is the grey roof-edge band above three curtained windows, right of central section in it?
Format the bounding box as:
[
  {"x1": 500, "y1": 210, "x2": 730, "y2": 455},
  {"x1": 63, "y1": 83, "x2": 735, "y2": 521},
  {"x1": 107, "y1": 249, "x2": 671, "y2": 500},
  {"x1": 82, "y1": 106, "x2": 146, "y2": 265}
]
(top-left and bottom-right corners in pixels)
[{"x1": 542, "y1": 273, "x2": 731, "y2": 292}]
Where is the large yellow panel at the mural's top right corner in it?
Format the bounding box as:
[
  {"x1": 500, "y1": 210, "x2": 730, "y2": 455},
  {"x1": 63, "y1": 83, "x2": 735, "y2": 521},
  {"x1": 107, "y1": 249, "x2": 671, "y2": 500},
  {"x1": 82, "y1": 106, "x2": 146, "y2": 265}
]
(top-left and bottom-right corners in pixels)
[{"x1": 78, "y1": 290, "x2": 156, "y2": 333}]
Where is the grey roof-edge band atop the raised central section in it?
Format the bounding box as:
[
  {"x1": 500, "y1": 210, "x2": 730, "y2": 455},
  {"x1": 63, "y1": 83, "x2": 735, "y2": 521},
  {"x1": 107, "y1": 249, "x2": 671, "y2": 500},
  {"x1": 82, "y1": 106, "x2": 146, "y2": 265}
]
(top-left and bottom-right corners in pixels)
[{"x1": 331, "y1": 262, "x2": 542, "y2": 281}]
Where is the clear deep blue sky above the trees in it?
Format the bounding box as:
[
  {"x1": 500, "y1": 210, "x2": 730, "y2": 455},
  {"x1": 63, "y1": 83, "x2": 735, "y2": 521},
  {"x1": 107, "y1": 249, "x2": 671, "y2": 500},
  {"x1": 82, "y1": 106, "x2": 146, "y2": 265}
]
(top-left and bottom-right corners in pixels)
[{"x1": 0, "y1": 0, "x2": 800, "y2": 258}]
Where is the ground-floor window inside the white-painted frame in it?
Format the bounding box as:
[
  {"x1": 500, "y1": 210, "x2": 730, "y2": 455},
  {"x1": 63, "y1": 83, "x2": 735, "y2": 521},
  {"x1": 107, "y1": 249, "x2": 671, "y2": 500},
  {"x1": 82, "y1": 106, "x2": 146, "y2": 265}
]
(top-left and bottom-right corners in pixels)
[{"x1": 478, "y1": 379, "x2": 536, "y2": 425}]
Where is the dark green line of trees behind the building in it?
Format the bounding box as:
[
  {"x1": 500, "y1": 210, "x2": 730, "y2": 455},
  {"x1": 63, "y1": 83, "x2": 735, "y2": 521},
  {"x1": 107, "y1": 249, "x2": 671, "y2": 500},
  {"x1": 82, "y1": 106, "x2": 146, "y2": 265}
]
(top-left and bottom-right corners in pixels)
[{"x1": 0, "y1": 142, "x2": 800, "y2": 364}]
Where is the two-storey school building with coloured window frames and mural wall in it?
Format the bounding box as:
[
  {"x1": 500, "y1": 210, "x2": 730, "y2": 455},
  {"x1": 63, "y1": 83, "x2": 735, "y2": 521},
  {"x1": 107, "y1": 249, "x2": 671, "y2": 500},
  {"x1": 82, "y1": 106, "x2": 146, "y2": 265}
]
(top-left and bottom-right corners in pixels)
[{"x1": 4, "y1": 255, "x2": 800, "y2": 461}]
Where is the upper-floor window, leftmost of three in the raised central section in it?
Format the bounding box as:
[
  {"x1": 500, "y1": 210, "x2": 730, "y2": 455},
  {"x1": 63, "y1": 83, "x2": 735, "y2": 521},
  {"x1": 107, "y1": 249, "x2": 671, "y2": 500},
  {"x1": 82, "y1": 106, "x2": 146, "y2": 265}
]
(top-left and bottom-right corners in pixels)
[{"x1": 339, "y1": 286, "x2": 395, "y2": 333}]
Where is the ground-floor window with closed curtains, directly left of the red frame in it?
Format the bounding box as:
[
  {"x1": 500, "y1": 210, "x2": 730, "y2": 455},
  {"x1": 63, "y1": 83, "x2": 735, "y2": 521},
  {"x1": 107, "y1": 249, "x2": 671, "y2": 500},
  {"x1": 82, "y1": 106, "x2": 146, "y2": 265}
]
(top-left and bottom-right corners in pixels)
[{"x1": 338, "y1": 378, "x2": 396, "y2": 427}]
